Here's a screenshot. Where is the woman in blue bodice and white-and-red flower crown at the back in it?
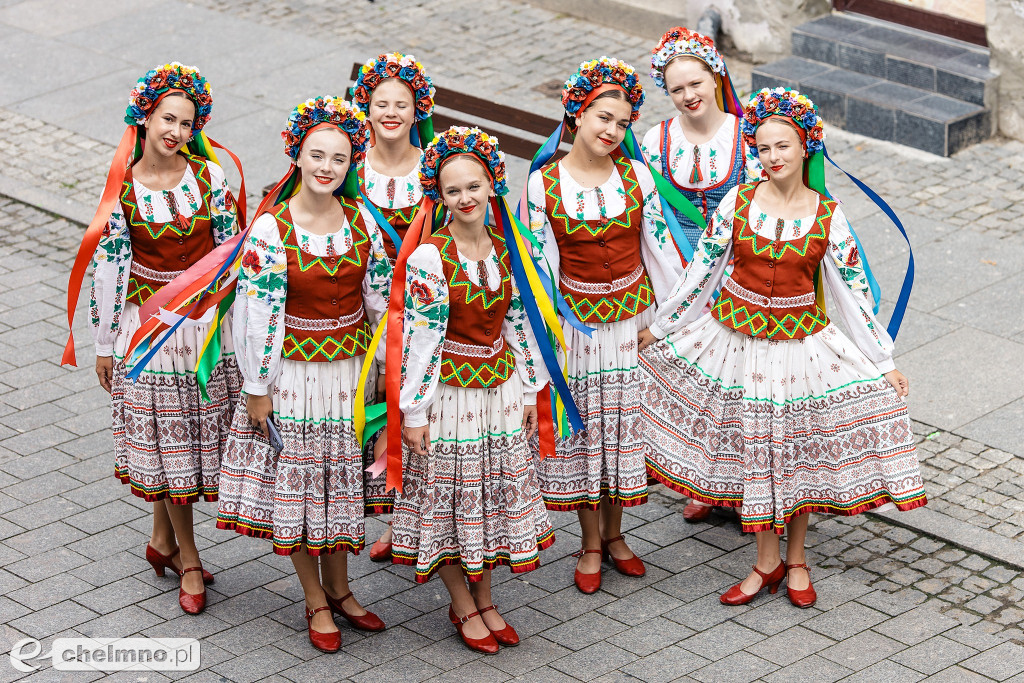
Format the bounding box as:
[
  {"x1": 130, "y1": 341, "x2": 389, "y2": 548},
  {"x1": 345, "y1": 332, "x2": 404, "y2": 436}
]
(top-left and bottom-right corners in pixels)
[{"x1": 640, "y1": 27, "x2": 761, "y2": 522}]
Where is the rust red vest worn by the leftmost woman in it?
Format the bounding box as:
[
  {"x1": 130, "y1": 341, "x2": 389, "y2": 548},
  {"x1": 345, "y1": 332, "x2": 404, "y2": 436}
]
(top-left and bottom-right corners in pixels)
[{"x1": 121, "y1": 155, "x2": 216, "y2": 306}]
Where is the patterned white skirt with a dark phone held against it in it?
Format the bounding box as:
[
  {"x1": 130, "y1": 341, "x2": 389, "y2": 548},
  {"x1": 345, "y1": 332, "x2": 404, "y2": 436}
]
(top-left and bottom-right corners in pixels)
[{"x1": 217, "y1": 356, "x2": 373, "y2": 555}]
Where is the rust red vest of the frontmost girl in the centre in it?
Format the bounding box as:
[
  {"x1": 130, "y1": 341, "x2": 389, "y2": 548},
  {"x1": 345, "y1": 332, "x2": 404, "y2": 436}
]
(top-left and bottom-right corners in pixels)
[{"x1": 426, "y1": 227, "x2": 515, "y2": 389}]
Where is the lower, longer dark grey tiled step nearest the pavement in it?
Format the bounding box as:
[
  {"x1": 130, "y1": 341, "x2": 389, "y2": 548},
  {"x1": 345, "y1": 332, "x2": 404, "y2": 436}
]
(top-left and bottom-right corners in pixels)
[{"x1": 752, "y1": 55, "x2": 992, "y2": 157}]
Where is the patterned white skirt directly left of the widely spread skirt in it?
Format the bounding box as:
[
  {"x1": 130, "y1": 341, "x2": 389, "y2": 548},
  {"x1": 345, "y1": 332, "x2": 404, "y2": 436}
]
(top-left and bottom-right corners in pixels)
[{"x1": 535, "y1": 307, "x2": 654, "y2": 510}]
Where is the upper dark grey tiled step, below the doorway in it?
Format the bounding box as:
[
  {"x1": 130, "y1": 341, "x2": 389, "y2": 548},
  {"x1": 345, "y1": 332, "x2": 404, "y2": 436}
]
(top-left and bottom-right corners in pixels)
[{"x1": 793, "y1": 14, "x2": 998, "y2": 109}]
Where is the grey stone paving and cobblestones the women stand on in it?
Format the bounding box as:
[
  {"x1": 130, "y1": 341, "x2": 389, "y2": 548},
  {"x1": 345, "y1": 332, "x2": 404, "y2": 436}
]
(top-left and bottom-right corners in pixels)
[{"x1": 0, "y1": 0, "x2": 1024, "y2": 683}]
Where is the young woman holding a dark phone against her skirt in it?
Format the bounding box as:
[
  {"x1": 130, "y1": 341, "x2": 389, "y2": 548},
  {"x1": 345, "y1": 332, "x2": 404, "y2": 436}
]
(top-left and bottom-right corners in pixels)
[{"x1": 217, "y1": 96, "x2": 391, "y2": 652}]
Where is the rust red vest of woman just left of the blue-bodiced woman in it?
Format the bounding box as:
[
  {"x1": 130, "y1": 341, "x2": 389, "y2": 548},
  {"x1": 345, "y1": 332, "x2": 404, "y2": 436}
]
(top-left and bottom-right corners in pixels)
[{"x1": 542, "y1": 158, "x2": 654, "y2": 323}]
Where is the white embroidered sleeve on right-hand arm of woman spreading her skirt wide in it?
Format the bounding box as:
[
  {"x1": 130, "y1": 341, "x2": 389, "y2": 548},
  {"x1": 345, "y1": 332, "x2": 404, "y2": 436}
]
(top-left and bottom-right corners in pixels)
[{"x1": 821, "y1": 206, "x2": 896, "y2": 374}]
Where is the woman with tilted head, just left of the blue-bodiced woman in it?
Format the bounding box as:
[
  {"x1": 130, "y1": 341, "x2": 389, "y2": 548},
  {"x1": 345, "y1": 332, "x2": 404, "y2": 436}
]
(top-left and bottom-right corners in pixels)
[{"x1": 527, "y1": 57, "x2": 682, "y2": 593}]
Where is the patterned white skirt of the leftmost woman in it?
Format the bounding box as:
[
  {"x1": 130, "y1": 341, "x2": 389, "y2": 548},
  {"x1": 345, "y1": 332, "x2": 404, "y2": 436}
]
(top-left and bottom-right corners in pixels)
[{"x1": 111, "y1": 303, "x2": 242, "y2": 505}]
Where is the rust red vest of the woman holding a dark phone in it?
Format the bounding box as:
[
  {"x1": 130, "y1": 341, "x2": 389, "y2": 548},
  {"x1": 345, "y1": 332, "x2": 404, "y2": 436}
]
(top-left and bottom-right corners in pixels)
[{"x1": 273, "y1": 198, "x2": 373, "y2": 362}]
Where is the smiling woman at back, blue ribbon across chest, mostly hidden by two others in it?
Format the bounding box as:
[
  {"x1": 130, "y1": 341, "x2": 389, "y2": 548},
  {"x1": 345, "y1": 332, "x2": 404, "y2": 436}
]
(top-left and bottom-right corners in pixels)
[{"x1": 352, "y1": 52, "x2": 434, "y2": 562}]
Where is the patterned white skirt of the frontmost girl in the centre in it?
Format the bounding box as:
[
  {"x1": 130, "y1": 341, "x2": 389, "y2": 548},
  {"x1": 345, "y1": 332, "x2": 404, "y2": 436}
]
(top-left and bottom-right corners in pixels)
[{"x1": 391, "y1": 375, "x2": 555, "y2": 583}]
